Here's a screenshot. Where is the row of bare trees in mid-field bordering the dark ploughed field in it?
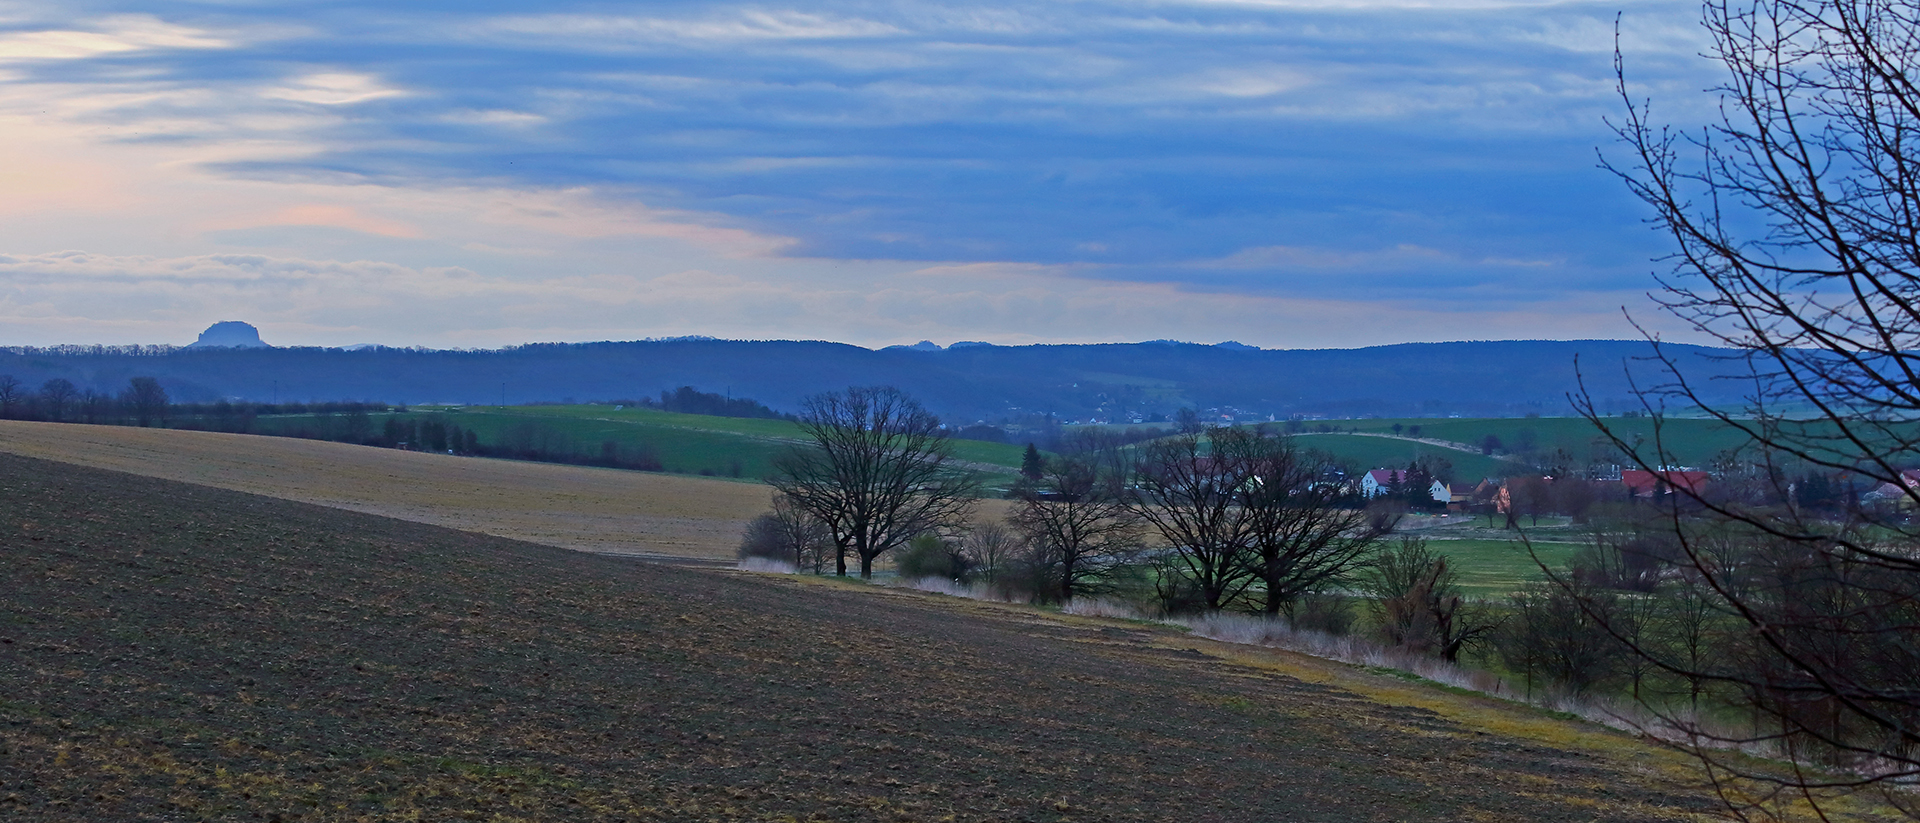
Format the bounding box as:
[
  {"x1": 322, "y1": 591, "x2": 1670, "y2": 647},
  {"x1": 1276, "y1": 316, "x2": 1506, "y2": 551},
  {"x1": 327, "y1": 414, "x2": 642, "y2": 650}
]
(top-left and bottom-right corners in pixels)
[{"x1": 741, "y1": 388, "x2": 1436, "y2": 616}]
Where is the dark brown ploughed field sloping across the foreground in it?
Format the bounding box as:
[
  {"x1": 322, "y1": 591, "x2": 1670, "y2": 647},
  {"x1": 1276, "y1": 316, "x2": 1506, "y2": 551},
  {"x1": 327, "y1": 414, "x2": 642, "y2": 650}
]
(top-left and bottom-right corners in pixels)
[{"x1": 0, "y1": 455, "x2": 1728, "y2": 821}]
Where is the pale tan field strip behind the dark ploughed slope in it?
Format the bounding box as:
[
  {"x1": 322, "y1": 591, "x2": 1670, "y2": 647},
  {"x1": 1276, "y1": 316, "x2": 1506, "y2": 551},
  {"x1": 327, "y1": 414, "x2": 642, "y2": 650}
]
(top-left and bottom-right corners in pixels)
[{"x1": 0, "y1": 420, "x2": 772, "y2": 558}]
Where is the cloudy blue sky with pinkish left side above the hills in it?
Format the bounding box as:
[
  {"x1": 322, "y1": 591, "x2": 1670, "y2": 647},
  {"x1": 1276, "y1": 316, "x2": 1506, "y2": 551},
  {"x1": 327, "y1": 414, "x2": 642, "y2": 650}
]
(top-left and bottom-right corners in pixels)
[{"x1": 0, "y1": 0, "x2": 1715, "y2": 347}]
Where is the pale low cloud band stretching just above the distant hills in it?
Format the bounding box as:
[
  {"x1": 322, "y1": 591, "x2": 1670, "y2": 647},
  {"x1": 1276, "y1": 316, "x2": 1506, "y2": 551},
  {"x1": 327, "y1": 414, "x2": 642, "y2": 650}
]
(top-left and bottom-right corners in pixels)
[{"x1": 0, "y1": 243, "x2": 1681, "y2": 347}]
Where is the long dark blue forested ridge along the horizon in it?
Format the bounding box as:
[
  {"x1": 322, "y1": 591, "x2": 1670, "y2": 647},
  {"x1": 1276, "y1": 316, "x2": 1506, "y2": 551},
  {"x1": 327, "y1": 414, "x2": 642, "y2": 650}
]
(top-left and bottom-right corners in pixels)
[{"x1": 0, "y1": 337, "x2": 1740, "y2": 422}]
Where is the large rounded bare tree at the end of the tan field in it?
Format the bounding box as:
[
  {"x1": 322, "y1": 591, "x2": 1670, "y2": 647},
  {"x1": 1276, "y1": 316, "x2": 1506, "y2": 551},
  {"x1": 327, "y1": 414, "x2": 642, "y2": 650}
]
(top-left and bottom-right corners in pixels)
[{"x1": 770, "y1": 388, "x2": 977, "y2": 577}]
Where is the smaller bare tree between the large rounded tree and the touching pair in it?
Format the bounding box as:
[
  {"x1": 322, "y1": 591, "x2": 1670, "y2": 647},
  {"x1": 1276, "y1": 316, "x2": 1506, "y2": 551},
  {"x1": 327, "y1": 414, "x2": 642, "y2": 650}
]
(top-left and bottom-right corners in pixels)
[{"x1": 1008, "y1": 443, "x2": 1139, "y2": 602}]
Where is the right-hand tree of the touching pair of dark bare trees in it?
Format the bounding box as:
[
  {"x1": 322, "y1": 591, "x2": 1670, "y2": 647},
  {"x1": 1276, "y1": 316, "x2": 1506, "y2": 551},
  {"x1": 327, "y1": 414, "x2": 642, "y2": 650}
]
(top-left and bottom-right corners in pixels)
[{"x1": 1236, "y1": 430, "x2": 1392, "y2": 618}]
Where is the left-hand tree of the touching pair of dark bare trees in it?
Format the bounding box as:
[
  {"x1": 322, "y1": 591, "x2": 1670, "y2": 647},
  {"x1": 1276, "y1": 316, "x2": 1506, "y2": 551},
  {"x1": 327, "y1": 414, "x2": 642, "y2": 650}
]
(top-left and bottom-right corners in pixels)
[{"x1": 1129, "y1": 428, "x2": 1254, "y2": 608}]
